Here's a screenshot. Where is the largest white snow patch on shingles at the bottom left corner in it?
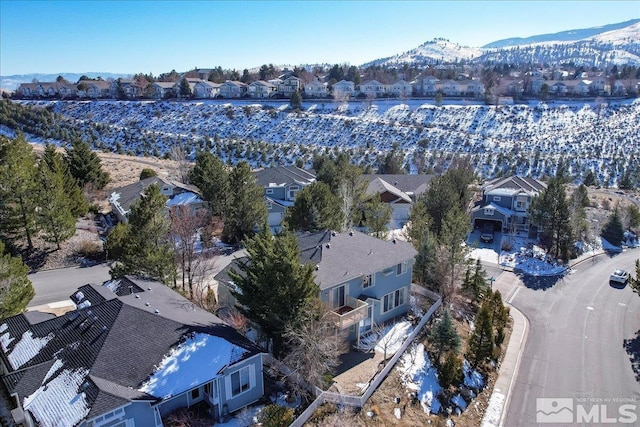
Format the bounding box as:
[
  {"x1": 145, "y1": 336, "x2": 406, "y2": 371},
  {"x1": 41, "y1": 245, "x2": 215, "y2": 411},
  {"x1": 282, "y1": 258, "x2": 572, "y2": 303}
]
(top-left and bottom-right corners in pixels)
[{"x1": 23, "y1": 360, "x2": 89, "y2": 427}]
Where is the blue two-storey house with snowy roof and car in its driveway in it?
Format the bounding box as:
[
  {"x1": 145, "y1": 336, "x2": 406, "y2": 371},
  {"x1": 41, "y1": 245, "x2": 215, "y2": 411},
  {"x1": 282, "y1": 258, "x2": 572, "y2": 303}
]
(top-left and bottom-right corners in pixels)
[{"x1": 471, "y1": 176, "x2": 547, "y2": 235}]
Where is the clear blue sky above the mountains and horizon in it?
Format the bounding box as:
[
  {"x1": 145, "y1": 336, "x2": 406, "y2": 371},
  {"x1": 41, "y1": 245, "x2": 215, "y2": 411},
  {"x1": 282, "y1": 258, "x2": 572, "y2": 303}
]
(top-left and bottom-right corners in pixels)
[{"x1": 0, "y1": 0, "x2": 640, "y2": 76}]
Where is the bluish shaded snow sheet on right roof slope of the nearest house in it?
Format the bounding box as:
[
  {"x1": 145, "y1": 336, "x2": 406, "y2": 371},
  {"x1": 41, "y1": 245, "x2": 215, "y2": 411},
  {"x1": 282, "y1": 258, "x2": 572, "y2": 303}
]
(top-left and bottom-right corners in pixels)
[{"x1": 138, "y1": 333, "x2": 248, "y2": 399}]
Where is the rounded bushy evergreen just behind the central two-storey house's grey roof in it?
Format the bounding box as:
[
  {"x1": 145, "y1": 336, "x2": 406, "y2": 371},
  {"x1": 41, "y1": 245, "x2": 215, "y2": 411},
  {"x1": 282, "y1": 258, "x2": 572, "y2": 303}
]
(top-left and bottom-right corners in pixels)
[{"x1": 284, "y1": 182, "x2": 343, "y2": 232}]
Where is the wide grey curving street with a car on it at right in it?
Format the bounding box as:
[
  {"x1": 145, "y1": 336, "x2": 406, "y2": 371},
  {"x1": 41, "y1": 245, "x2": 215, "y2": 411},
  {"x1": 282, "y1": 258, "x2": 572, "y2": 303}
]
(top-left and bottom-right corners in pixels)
[{"x1": 500, "y1": 249, "x2": 640, "y2": 426}]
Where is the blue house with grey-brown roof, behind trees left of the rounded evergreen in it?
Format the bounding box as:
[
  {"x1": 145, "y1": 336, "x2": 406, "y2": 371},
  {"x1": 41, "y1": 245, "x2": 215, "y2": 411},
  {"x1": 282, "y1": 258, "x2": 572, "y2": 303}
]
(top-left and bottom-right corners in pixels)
[{"x1": 254, "y1": 166, "x2": 316, "y2": 232}]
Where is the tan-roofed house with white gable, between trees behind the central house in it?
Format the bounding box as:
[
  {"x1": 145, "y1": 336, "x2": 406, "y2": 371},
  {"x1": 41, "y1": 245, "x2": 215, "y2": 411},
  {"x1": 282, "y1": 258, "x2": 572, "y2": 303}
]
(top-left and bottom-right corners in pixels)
[{"x1": 363, "y1": 174, "x2": 433, "y2": 228}]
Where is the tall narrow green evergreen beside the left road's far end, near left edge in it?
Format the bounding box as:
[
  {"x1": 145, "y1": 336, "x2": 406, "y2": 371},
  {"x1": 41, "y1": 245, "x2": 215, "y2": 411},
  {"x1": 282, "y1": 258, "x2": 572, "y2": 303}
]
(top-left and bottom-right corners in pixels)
[{"x1": 37, "y1": 161, "x2": 76, "y2": 249}]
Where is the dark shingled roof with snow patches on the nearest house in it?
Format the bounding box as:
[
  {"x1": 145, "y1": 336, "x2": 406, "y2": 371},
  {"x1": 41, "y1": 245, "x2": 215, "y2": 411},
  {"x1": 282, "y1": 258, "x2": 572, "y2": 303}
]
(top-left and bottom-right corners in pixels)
[{"x1": 0, "y1": 278, "x2": 262, "y2": 426}]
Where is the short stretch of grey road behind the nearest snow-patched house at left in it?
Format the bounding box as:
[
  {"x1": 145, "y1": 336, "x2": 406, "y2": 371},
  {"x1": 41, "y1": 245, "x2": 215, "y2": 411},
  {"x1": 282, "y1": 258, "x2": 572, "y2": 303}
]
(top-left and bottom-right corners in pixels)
[{"x1": 29, "y1": 264, "x2": 111, "y2": 307}]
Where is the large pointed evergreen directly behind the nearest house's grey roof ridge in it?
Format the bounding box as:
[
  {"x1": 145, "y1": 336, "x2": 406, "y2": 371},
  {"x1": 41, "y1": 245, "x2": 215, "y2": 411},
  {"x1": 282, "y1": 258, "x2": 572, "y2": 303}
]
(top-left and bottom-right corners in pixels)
[{"x1": 107, "y1": 184, "x2": 176, "y2": 283}]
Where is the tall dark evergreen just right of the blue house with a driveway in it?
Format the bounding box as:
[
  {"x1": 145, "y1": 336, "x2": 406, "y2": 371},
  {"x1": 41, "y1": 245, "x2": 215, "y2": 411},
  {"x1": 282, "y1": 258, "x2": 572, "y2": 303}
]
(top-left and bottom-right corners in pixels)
[{"x1": 529, "y1": 177, "x2": 573, "y2": 261}]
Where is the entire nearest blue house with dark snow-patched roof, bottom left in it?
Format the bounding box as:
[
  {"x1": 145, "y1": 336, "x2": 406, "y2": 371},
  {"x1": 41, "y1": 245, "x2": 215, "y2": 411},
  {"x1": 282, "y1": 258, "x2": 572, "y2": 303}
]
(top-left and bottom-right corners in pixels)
[{"x1": 0, "y1": 277, "x2": 265, "y2": 427}]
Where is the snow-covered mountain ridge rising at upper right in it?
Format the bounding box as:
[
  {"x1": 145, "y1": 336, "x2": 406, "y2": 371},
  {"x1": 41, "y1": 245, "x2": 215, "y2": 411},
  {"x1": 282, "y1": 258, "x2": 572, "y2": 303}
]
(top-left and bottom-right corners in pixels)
[{"x1": 363, "y1": 19, "x2": 640, "y2": 67}]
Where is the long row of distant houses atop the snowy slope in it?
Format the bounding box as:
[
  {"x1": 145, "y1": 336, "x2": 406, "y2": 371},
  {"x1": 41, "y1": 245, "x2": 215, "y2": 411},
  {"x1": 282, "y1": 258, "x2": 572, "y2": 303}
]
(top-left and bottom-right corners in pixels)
[{"x1": 13, "y1": 66, "x2": 640, "y2": 100}]
